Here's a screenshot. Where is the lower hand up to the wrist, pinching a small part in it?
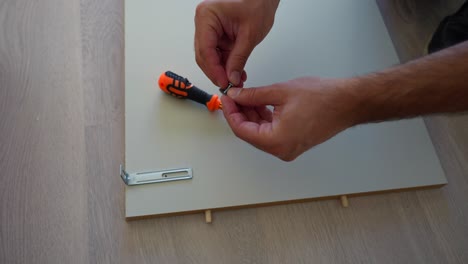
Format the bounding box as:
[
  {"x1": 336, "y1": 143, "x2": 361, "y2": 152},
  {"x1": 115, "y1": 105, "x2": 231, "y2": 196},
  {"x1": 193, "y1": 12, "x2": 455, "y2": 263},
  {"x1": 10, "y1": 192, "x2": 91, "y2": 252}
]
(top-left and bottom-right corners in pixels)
[{"x1": 221, "y1": 77, "x2": 358, "y2": 161}]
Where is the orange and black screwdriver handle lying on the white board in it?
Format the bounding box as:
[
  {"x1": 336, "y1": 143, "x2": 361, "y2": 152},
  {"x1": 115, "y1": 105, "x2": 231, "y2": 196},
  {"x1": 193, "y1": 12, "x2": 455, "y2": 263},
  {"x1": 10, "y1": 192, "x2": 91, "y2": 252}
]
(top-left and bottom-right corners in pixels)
[{"x1": 158, "y1": 71, "x2": 223, "y2": 111}]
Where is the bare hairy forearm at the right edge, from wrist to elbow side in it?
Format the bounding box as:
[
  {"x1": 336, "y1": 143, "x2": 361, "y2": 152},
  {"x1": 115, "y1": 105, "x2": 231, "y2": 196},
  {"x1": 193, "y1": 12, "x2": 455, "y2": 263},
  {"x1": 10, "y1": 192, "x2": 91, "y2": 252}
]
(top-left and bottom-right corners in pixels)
[{"x1": 348, "y1": 42, "x2": 468, "y2": 123}]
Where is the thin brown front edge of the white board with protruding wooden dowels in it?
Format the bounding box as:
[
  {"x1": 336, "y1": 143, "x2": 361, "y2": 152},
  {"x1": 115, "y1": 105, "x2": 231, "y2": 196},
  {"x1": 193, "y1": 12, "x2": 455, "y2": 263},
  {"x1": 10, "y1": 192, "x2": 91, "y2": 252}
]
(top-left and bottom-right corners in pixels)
[{"x1": 125, "y1": 183, "x2": 446, "y2": 223}]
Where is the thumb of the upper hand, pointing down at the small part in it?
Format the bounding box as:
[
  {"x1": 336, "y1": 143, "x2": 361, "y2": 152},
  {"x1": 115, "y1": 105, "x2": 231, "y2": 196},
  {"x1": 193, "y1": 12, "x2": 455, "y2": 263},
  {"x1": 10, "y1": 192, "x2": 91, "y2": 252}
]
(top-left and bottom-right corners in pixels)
[{"x1": 226, "y1": 30, "x2": 255, "y2": 86}]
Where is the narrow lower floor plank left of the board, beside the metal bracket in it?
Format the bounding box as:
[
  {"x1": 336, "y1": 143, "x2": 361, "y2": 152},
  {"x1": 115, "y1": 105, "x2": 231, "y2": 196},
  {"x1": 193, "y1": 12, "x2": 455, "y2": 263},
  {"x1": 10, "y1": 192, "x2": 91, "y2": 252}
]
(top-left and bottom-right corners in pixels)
[{"x1": 85, "y1": 124, "x2": 124, "y2": 263}]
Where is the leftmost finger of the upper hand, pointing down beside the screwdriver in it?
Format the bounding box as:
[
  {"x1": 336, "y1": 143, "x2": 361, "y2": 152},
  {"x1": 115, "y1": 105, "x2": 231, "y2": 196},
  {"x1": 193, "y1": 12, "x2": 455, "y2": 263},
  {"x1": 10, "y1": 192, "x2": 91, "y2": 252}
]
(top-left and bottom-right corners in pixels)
[{"x1": 195, "y1": 16, "x2": 228, "y2": 87}]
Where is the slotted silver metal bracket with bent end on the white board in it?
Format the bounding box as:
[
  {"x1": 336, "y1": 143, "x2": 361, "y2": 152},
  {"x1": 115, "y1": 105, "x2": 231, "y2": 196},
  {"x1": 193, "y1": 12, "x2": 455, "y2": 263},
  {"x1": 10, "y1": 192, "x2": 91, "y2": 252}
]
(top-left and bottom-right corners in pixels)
[{"x1": 120, "y1": 165, "x2": 193, "y2": 186}]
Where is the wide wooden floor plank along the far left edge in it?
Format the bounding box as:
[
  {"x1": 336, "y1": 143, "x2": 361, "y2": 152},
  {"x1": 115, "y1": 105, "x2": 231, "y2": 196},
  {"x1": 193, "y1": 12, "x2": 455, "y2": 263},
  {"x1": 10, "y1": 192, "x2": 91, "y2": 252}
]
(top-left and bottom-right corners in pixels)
[{"x1": 0, "y1": 0, "x2": 88, "y2": 263}]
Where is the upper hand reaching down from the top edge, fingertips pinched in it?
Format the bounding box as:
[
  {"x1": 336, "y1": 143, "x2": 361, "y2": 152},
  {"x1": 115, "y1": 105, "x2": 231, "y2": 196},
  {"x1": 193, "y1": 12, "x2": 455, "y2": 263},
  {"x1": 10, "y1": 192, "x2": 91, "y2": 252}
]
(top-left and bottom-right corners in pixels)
[{"x1": 195, "y1": 0, "x2": 279, "y2": 88}]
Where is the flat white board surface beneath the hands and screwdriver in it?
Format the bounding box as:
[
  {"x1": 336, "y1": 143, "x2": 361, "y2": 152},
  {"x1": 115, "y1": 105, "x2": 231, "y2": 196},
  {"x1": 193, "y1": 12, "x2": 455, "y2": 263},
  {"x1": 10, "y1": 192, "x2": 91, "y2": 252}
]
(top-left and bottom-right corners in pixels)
[{"x1": 125, "y1": 0, "x2": 446, "y2": 217}]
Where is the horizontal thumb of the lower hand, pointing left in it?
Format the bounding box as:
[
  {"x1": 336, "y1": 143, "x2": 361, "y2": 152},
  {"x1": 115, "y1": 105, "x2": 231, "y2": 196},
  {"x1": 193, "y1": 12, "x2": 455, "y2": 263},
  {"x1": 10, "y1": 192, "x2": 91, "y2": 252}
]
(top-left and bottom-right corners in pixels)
[{"x1": 228, "y1": 85, "x2": 286, "y2": 106}]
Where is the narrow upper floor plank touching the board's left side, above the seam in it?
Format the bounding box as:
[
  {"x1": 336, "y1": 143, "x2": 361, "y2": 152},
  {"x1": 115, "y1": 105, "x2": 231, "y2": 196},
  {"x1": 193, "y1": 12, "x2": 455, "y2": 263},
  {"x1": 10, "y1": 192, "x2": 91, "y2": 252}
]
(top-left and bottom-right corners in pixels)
[{"x1": 80, "y1": 0, "x2": 124, "y2": 125}]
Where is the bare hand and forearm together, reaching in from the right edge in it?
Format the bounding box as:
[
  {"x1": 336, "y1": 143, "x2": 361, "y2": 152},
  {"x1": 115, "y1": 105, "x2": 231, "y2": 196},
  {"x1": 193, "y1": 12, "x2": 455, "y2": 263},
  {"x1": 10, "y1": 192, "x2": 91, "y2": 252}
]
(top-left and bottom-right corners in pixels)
[{"x1": 221, "y1": 41, "x2": 468, "y2": 161}]
